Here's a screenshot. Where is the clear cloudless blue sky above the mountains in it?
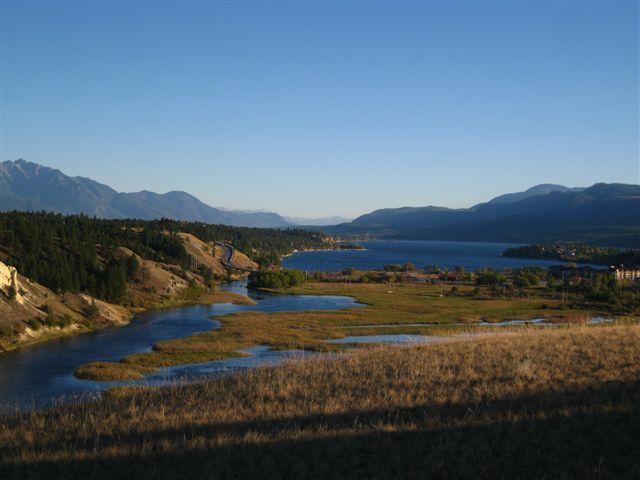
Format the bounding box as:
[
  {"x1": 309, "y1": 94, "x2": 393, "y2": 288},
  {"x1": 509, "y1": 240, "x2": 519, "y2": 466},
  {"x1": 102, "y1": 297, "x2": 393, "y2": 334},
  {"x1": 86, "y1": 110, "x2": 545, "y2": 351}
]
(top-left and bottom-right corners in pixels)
[{"x1": 0, "y1": 0, "x2": 639, "y2": 216}]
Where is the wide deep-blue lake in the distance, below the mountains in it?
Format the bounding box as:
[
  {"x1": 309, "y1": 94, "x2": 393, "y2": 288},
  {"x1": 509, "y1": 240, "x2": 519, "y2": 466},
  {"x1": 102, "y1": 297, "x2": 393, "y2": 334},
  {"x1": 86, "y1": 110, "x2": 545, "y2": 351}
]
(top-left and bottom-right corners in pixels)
[{"x1": 282, "y1": 240, "x2": 562, "y2": 271}]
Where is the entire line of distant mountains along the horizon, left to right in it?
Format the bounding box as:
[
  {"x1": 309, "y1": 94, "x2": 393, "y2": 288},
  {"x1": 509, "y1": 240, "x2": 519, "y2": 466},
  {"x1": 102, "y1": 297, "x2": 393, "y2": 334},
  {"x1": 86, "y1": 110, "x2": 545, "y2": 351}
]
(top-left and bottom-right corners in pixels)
[{"x1": 0, "y1": 160, "x2": 640, "y2": 248}]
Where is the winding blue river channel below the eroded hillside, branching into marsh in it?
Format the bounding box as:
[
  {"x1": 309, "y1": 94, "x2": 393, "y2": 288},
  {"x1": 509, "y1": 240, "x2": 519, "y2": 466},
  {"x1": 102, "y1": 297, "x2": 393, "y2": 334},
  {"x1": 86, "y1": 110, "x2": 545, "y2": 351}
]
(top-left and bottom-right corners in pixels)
[{"x1": 0, "y1": 282, "x2": 360, "y2": 409}]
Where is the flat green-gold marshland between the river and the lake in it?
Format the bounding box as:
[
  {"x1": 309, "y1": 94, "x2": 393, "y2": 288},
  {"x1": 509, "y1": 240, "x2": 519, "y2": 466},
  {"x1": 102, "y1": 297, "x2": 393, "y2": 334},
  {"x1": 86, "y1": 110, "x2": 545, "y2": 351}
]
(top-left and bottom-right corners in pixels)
[{"x1": 76, "y1": 282, "x2": 628, "y2": 381}]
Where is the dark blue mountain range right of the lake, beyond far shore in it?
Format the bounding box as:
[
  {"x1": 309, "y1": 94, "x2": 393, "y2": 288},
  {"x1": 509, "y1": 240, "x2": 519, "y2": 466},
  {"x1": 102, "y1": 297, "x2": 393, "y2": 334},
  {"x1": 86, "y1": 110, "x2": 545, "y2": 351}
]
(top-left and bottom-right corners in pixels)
[{"x1": 323, "y1": 183, "x2": 640, "y2": 248}]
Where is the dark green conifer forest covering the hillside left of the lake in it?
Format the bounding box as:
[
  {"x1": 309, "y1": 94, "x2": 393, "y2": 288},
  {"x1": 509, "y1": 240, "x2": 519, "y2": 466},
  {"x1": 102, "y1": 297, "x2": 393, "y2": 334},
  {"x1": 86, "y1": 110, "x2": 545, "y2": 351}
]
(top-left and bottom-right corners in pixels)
[{"x1": 0, "y1": 212, "x2": 324, "y2": 303}]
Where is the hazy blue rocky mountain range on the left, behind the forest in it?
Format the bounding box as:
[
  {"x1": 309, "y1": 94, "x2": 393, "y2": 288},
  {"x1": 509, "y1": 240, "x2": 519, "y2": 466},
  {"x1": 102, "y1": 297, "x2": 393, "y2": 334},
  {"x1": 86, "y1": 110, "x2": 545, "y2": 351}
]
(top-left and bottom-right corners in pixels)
[{"x1": 0, "y1": 159, "x2": 291, "y2": 227}]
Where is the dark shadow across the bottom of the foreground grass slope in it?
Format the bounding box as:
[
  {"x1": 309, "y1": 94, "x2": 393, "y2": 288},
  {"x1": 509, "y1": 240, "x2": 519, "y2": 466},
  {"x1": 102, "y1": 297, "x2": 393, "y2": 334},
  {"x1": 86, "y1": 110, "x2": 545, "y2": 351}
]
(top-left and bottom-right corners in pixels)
[{"x1": 0, "y1": 382, "x2": 640, "y2": 479}]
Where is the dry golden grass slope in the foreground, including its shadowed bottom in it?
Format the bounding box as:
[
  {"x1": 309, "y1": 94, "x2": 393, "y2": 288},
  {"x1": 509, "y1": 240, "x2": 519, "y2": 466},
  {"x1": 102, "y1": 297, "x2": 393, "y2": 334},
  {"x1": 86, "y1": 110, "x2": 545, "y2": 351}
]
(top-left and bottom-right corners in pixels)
[{"x1": 0, "y1": 326, "x2": 640, "y2": 479}]
